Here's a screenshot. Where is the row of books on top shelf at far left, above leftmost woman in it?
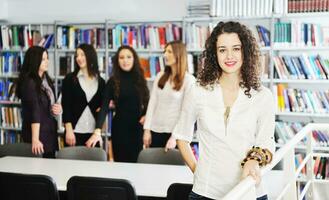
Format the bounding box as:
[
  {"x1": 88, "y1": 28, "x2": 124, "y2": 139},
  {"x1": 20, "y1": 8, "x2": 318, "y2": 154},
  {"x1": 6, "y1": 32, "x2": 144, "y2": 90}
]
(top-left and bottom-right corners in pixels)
[{"x1": 0, "y1": 25, "x2": 54, "y2": 50}]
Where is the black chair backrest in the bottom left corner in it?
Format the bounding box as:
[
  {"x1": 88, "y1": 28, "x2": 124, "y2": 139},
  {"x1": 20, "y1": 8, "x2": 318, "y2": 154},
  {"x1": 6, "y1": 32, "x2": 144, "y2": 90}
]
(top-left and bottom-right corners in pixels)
[{"x1": 0, "y1": 172, "x2": 59, "y2": 200}]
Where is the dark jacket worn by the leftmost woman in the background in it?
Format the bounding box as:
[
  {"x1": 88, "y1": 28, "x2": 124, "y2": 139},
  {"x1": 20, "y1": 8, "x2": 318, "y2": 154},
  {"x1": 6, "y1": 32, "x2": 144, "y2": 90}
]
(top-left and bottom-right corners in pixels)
[{"x1": 20, "y1": 78, "x2": 58, "y2": 152}]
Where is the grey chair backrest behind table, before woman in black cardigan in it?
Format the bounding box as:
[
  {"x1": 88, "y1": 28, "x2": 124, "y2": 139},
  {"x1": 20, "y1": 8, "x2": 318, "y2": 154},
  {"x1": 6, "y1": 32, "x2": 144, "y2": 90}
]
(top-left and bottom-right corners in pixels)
[{"x1": 56, "y1": 146, "x2": 107, "y2": 161}]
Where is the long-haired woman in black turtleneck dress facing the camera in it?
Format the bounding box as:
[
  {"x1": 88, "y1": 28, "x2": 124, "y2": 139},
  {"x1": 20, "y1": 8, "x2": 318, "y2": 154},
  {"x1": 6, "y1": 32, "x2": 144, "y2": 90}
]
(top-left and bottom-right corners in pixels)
[{"x1": 87, "y1": 46, "x2": 149, "y2": 162}]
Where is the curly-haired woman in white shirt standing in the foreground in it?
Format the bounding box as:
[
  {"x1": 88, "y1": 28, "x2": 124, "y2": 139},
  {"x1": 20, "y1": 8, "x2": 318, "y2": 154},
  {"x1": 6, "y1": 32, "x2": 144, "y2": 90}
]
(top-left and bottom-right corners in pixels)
[{"x1": 173, "y1": 22, "x2": 275, "y2": 200}]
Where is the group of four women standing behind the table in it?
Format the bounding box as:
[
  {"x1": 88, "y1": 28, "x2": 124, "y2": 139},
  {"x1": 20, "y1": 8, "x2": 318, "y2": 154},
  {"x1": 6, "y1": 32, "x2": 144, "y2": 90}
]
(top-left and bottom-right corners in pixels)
[{"x1": 17, "y1": 41, "x2": 194, "y2": 162}]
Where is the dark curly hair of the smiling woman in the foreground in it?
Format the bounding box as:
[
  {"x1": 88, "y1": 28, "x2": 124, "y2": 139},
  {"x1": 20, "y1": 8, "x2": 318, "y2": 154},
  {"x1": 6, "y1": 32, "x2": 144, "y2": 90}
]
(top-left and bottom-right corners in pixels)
[{"x1": 197, "y1": 21, "x2": 260, "y2": 98}]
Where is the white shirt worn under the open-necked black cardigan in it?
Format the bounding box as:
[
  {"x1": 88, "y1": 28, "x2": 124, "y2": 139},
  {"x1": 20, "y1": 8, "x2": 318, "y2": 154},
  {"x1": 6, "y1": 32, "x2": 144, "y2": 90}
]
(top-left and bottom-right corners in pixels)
[{"x1": 74, "y1": 70, "x2": 98, "y2": 133}]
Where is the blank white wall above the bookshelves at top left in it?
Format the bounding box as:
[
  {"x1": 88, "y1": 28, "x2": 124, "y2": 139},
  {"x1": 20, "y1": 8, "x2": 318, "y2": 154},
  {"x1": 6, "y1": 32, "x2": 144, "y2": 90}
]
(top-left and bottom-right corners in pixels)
[{"x1": 6, "y1": 0, "x2": 186, "y2": 23}]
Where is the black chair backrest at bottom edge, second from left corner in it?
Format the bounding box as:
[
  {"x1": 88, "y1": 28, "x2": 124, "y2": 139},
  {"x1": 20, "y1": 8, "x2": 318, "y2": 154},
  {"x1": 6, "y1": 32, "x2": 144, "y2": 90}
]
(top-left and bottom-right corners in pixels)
[{"x1": 66, "y1": 176, "x2": 137, "y2": 200}]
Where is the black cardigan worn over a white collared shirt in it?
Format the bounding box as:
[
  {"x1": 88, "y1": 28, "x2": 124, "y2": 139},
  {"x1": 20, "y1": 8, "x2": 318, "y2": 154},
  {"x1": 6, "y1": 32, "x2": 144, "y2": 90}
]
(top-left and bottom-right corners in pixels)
[{"x1": 62, "y1": 73, "x2": 105, "y2": 129}]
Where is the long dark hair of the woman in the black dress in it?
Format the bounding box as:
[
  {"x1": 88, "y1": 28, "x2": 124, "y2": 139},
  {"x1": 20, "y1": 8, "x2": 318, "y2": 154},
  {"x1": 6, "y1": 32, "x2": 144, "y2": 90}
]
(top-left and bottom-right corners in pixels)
[{"x1": 110, "y1": 45, "x2": 150, "y2": 111}]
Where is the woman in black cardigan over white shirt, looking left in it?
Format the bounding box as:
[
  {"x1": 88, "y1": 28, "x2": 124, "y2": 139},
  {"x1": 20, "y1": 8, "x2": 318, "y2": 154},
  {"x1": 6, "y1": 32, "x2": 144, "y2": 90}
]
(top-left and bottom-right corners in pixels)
[{"x1": 62, "y1": 44, "x2": 105, "y2": 146}]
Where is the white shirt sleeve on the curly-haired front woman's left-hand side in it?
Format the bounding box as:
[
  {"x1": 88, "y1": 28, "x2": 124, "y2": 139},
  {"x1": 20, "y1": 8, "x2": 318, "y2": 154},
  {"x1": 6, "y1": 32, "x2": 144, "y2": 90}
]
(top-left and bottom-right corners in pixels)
[{"x1": 172, "y1": 84, "x2": 198, "y2": 142}]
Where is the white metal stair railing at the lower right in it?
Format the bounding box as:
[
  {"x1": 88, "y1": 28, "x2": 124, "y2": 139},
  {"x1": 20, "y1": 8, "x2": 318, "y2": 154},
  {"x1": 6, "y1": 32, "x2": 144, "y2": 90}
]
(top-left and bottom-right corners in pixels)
[{"x1": 223, "y1": 123, "x2": 329, "y2": 200}]
